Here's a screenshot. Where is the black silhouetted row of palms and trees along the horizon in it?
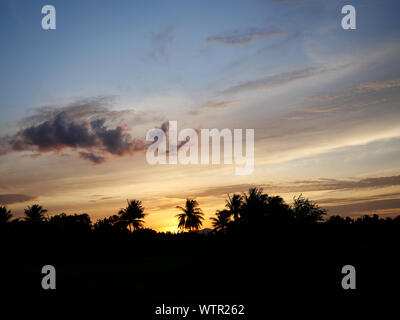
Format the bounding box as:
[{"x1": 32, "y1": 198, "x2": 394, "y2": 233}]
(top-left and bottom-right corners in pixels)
[{"x1": 0, "y1": 188, "x2": 400, "y2": 233}]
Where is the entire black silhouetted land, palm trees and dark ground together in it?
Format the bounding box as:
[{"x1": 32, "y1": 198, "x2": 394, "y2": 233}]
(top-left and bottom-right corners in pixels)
[{"x1": 0, "y1": 188, "x2": 400, "y2": 300}]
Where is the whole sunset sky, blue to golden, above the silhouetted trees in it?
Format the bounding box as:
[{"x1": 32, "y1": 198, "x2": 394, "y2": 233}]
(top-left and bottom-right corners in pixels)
[{"x1": 0, "y1": 0, "x2": 400, "y2": 231}]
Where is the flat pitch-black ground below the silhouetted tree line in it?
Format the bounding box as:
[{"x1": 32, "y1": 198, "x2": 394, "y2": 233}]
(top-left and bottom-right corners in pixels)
[{"x1": 0, "y1": 225, "x2": 400, "y2": 302}]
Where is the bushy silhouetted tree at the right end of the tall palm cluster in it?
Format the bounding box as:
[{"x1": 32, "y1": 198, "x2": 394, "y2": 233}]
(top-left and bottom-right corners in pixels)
[{"x1": 293, "y1": 194, "x2": 326, "y2": 224}]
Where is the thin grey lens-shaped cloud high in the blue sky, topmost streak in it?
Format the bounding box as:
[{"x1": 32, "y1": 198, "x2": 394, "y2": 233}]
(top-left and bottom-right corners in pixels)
[{"x1": 206, "y1": 28, "x2": 287, "y2": 46}]
